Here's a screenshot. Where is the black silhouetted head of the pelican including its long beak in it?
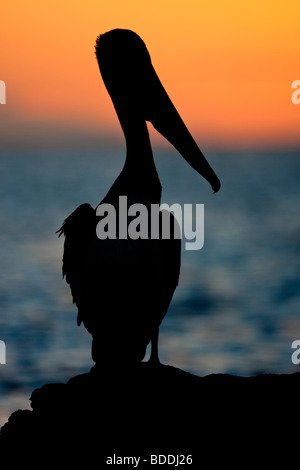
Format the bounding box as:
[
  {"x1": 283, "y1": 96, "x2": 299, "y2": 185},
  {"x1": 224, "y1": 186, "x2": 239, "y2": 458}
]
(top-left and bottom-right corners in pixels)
[{"x1": 95, "y1": 29, "x2": 220, "y2": 192}]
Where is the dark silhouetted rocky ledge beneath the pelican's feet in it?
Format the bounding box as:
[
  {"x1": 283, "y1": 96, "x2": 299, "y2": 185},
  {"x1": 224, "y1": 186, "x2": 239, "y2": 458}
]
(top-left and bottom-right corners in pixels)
[{"x1": 0, "y1": 363, "x2": 300, "y2": 469}]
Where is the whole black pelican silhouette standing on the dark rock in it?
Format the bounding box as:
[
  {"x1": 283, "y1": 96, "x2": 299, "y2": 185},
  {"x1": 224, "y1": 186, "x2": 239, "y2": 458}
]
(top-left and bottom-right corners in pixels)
[{"x1": 58, "y1": 29, "x2": 220, "y2": 363}]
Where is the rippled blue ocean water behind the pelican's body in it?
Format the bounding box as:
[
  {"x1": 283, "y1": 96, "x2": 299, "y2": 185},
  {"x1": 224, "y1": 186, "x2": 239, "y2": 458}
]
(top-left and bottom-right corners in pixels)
[{"x1": 0, "y1": 150, "x2": 300, "y2": 426}]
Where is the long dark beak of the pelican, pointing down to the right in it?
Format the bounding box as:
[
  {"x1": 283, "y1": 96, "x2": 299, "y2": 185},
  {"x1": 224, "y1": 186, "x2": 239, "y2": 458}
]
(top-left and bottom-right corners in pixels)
[{"x1": 146, "y1": 67, "x2": 221, "y2": 193}]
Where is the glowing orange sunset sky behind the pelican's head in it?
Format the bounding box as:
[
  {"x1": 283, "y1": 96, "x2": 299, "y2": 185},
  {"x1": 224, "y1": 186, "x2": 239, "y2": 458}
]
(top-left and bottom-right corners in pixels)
[{"x1": 0, "y1": 0, "x2": 300, "y2": 147}]
